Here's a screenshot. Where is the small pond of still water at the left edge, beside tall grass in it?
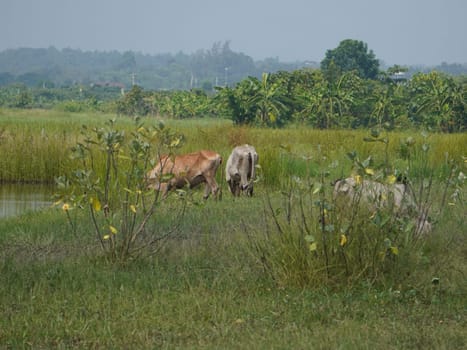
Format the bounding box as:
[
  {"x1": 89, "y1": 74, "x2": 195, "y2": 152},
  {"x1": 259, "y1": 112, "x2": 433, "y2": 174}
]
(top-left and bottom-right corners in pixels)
[{"x1": 0, "y1": 184, "x2": 54, "y2": 219}]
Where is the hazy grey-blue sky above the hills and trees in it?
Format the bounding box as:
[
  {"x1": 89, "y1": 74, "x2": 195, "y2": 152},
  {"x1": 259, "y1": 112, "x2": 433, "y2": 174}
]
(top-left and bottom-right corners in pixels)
[{"x1": 0, "y1": 0, "x2": 467, "y2": 65}]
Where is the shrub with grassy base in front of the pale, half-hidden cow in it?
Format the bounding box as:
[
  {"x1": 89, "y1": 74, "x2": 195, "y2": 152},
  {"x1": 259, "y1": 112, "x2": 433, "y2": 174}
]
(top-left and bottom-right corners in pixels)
[{"x1": 247, "y1": 133, "x2": 465, "y2": 287}]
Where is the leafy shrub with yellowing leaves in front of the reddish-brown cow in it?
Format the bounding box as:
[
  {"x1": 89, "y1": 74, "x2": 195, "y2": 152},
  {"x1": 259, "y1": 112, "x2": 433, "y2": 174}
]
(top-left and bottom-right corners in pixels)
[{"x1": 56, "y1": 119, "x2": 183, "y2": 262}]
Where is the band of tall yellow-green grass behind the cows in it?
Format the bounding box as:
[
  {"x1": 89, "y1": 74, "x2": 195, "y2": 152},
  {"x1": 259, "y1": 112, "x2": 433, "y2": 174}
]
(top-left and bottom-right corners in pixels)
[{"x1": 0, "y1": 110, "x2": 467, "y2": 187}]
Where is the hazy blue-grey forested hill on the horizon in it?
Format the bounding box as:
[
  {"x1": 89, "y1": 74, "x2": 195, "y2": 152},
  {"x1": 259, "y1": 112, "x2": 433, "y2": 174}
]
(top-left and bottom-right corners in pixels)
[{"x1": 0, "y1": 42, "x2": 319, "y2": 89}]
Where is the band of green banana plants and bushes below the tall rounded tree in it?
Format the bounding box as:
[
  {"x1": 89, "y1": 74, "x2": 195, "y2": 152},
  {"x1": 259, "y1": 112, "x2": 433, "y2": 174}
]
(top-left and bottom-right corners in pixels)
[{"x1": 115, "y1": 69, "x2": 467, "y2": 132}]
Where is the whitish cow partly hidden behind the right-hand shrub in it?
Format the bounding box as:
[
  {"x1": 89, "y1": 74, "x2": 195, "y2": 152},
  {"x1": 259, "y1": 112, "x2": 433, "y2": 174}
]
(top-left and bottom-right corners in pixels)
[{"x1": 333, "y1": 176, "x2": 432, "y2": 235}]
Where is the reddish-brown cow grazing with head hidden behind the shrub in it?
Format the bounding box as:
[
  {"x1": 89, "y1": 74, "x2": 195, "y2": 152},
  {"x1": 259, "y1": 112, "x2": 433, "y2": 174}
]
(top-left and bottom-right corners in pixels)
[{"x1": 147, "y1": 150, "x2": 222, "y2": 199}]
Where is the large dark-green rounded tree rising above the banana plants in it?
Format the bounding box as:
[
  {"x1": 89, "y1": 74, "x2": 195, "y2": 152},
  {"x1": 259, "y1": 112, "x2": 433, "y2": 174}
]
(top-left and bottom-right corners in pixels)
[{"x1": 321, "y1": 39, "x2": 379, "y2": 79}]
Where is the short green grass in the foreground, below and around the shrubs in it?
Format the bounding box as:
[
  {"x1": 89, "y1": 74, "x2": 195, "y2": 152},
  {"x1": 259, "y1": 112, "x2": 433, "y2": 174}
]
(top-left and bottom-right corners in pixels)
[{"x1": 0, "y1": 198, "x2": 466, "y2": 349}]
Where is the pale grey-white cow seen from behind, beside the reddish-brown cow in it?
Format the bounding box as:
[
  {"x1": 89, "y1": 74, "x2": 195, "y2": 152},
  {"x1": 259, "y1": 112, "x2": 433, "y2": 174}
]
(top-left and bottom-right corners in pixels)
[{"x1": 225, "y1": 145, "x2": 258, "y2": 196}]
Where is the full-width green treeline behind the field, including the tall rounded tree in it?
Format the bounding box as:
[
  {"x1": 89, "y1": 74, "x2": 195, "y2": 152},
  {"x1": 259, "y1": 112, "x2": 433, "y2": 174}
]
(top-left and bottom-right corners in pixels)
[{"x1": 0, "y1": 39, "x2": 467, "y2": 132}]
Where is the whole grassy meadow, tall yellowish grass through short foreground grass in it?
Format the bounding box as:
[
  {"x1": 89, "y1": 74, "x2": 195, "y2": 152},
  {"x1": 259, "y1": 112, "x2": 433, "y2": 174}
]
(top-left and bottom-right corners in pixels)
[{"x1": 0, "y1": 110, "x2": 467, "y2": 349}]
